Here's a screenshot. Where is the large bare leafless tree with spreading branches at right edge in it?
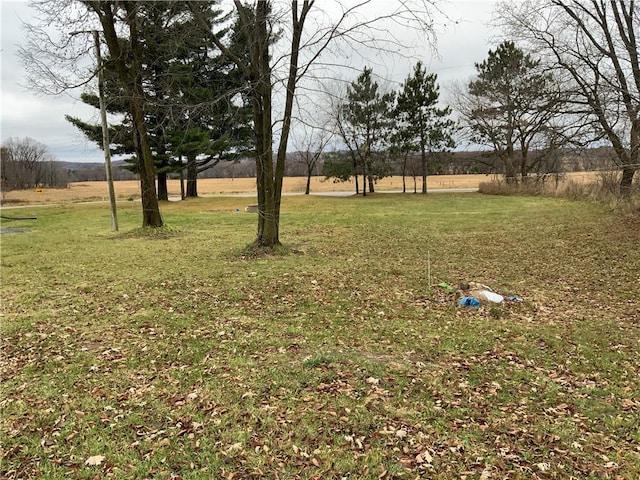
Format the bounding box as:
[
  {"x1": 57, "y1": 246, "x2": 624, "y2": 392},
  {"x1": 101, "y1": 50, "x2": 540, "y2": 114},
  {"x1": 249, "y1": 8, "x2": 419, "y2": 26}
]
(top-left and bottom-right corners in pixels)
[{"x1": 498, "y1": 0, "x2": 640, "y2": 194}]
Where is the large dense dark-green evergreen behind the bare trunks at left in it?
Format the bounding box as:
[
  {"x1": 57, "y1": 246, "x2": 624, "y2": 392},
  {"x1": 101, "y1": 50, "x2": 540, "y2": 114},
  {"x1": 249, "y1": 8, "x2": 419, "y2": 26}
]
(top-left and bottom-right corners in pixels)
[{"x1": 66, "y1": 2, "x2": 248, "y2": 200}]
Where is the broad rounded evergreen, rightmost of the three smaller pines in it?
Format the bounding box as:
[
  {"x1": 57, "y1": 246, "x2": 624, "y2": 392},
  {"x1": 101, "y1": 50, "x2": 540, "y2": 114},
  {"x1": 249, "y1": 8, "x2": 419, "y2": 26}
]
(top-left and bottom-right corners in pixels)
[{"x1": 458, "y1": 41, "x2": 564, "y2": 182}]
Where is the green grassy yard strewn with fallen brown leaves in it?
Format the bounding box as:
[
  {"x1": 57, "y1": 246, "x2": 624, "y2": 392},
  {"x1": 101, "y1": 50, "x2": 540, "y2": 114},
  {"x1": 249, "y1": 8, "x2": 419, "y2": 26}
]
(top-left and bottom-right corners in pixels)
[{"x1": 0, "y1": 194, "x2": 640, "y2": 480}]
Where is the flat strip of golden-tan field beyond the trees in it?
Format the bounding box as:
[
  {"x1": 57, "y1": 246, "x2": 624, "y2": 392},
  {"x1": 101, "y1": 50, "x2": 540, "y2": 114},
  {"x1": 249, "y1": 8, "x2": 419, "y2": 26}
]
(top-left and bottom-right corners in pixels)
[{"x1": 5, "y1": 172, "x2": 597, "y2": 204}]
